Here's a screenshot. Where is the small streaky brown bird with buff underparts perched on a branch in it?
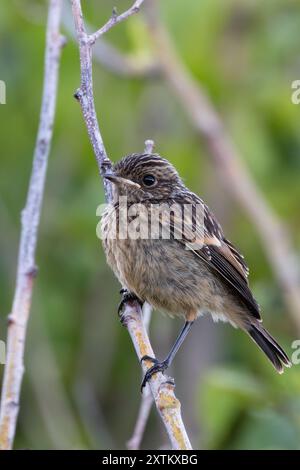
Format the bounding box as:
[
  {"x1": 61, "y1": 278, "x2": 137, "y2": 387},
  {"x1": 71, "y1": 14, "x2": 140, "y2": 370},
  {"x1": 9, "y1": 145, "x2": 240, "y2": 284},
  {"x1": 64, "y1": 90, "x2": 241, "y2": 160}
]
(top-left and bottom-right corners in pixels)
[{"x1": 101, "y1": 153, "x2": 291, "y2": 389}]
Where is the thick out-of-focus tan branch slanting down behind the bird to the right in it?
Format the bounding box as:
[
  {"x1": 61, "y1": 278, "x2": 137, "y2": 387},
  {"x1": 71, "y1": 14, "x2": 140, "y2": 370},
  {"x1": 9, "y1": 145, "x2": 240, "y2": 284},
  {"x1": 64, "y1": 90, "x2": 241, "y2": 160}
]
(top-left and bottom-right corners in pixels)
[{"x1": 146, "y1": 0, "x2": 300, "y2": 331}]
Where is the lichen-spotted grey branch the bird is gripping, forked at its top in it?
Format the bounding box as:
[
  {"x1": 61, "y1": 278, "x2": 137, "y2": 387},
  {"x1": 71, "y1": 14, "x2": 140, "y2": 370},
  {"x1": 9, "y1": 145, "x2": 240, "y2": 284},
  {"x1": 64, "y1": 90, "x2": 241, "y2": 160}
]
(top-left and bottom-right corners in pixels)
[{"x1": 72, "y1": 0, "x2": 191, "y2": 449}]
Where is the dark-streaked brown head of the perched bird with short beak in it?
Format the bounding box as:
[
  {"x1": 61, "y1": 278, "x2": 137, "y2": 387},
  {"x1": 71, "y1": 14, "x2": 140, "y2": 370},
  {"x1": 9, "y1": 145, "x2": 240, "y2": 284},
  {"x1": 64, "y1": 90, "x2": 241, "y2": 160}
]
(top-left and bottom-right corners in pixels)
[{"x1": 104, "y1": 153, "x2": 184, "y2": 203}]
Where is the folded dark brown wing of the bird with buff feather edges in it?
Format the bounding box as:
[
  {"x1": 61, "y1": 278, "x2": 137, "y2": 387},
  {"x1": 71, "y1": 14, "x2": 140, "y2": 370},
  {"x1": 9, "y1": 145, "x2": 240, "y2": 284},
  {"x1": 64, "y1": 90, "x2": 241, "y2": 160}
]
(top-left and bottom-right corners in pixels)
[{"x1": 166, "y1": 193, "x2": 261, "y2": 320}]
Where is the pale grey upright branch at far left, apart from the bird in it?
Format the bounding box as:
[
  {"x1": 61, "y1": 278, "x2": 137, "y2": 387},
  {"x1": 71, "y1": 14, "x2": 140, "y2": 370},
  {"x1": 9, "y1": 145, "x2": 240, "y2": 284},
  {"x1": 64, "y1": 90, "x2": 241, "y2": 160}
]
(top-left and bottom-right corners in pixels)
[{"x1": 0, "y1": 0, "x2": 64, "y2": 449}]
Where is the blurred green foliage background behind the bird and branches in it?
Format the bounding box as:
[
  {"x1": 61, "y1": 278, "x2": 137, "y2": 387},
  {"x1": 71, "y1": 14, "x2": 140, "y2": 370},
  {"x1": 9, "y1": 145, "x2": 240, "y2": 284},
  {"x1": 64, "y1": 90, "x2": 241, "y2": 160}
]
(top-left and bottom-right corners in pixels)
[{"x1": 0, "y1": 0, "x2": 300, "y2": 449}]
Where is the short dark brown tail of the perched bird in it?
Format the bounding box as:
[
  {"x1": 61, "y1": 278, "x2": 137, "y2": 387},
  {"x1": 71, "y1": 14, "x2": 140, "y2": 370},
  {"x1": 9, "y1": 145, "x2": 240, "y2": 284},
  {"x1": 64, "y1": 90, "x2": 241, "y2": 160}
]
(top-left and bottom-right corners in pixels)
[{"x1": 247, "y1": 323, "x2": 292, "y2": 374}]
